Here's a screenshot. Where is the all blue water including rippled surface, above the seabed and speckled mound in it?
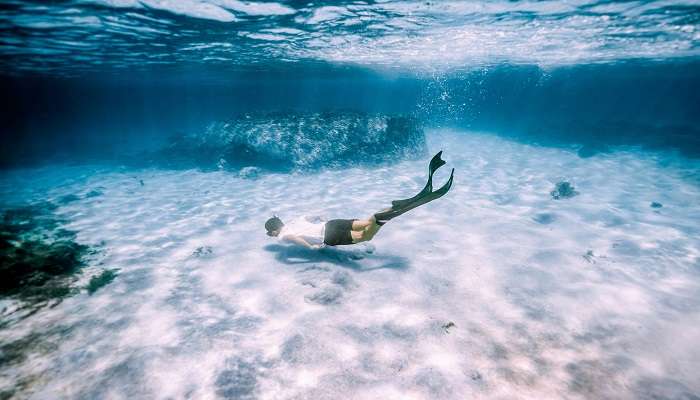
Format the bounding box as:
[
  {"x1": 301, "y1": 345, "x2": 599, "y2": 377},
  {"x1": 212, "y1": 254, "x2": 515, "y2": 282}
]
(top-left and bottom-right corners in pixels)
[{"x1": 0, "y1": 0, "x2": 700, "y2": 166}]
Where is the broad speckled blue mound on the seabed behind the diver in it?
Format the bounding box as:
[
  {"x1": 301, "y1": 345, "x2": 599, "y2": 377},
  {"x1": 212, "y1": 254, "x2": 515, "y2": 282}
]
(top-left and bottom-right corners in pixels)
[{"x1": 150, "y1": 112, "x2": 427, "y2": 171}]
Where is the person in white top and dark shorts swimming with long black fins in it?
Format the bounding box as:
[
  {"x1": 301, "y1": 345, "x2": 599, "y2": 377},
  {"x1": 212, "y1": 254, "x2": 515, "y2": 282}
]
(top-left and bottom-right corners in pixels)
[{"x1": 265, "y1": 151, "x2": 455, "y2": 249}]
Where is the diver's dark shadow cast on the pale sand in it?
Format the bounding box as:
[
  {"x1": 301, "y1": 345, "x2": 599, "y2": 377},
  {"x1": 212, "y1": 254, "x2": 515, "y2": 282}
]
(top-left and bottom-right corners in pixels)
[{"x1": 264, "y1": 244, "x2": 410, "y2": 272}]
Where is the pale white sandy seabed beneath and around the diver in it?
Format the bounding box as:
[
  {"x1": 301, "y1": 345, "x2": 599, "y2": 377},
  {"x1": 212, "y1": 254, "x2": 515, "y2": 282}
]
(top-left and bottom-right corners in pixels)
[{"x1": 0, "y1": 131, "x2": 700, "y2": 399}]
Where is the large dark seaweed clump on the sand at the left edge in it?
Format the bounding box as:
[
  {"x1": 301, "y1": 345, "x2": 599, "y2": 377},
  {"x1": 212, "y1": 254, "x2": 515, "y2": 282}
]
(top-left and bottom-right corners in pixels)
[{"x1": 0, "y1": 203, "x2": 90, "y2": 303}]
